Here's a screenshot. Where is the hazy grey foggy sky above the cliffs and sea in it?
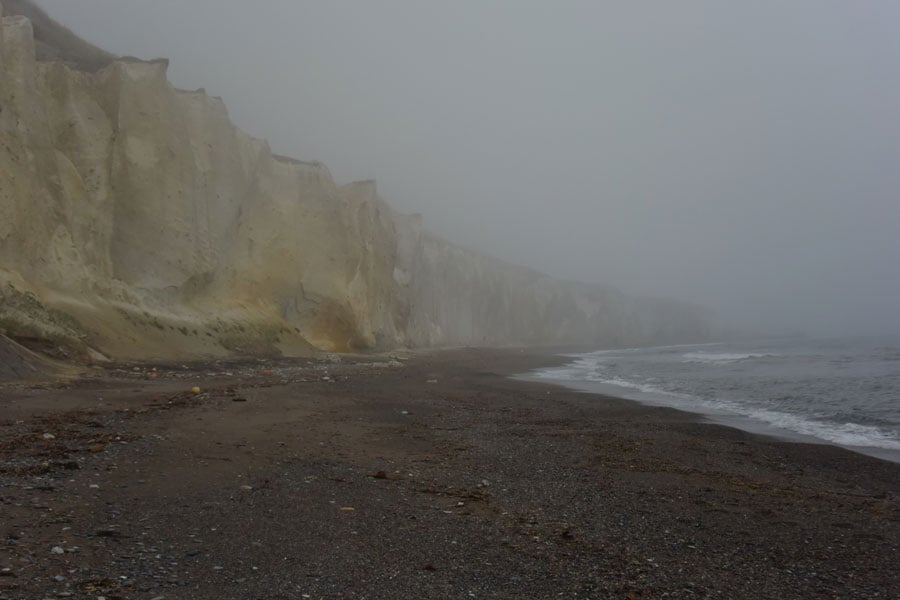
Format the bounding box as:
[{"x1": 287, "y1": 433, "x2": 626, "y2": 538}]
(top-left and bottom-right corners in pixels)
[{"x1": 39, "y1": 0, "x2": 900, "y2": 335}]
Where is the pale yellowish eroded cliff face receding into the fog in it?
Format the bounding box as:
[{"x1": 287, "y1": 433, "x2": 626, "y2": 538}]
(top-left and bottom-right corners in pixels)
[{"x1": 0, "y1": 5, "x2": 704, "y2": 359}]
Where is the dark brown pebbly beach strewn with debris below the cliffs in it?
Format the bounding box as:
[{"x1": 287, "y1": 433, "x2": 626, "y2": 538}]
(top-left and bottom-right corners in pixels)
[{"x1": 0, "y1": 349, "x2": 900, "y2": 599}]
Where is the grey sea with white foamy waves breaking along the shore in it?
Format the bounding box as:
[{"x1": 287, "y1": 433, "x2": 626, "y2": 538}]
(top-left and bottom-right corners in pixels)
[{"x1": 529, "y1": 337, "x2": 900, "y2": 462}]
